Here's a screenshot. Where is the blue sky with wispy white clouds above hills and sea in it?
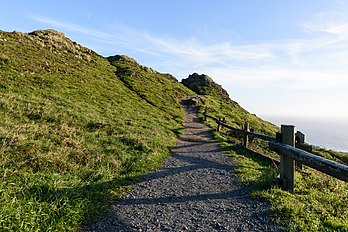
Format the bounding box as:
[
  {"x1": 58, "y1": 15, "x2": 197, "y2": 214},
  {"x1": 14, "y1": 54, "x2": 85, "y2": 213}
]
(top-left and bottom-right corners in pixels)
[{"x1": 0, "y1": 0, "x2": 348, "y2": 118}]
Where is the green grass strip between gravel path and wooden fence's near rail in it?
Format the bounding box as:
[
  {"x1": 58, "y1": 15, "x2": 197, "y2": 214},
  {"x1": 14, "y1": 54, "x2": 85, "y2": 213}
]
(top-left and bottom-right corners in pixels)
[{"x1": 225, "y1": 141, "x2": 348, "y2": 231}]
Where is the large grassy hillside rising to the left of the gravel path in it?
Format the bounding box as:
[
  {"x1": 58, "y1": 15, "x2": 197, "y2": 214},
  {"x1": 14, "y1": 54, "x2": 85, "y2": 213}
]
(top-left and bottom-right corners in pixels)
[{"x1": 0, "y1": 30, "x2": 191, "y2": 231}]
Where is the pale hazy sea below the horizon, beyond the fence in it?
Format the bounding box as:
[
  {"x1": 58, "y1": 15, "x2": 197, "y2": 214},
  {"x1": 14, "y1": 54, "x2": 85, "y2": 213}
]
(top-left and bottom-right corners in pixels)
[{"x1": 261, "y1": 115, "x2": 348, "y2": 152}]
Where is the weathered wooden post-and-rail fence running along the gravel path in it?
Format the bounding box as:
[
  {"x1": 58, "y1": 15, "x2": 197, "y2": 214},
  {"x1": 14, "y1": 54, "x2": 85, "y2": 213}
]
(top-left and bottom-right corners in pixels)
[{"x1": 203, "y1": 110, "x2": 348, "y2": 192}]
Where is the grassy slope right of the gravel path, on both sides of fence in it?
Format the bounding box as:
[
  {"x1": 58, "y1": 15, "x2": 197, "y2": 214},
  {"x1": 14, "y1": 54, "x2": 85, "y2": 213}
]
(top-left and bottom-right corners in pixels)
[{"x1": 183, "y1": 75, "x2": 348, "y2": 231}]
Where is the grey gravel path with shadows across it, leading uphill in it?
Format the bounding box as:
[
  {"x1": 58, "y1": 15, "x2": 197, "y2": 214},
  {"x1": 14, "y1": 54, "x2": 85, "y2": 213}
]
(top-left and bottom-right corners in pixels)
[{"x1": 83, "y1": 108, "x2": 281, "y2": 231}]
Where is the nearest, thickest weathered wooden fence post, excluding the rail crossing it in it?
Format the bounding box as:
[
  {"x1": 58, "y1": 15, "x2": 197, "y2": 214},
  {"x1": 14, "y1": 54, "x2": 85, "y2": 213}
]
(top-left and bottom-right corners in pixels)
[{"x1": 280, "y1": 125, "x2": 295, "y2": 193}]
